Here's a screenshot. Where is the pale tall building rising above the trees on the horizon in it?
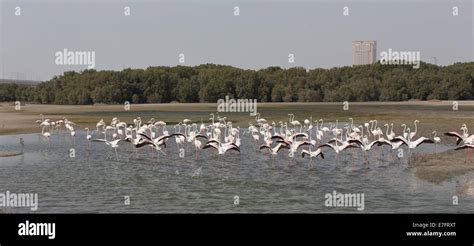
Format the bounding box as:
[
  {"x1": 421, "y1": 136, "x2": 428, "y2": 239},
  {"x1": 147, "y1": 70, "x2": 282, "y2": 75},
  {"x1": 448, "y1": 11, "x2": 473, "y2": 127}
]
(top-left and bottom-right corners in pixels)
[{"x1": 352, "y1": 40, "x2": 377, "y2": 66}]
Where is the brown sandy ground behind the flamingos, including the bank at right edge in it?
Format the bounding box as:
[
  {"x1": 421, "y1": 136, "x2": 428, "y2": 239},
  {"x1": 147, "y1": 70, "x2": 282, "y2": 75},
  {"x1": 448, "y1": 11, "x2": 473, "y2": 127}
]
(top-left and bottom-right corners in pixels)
[{"x1": 0, "y1": 101, "x2": 474, "y2": 183}]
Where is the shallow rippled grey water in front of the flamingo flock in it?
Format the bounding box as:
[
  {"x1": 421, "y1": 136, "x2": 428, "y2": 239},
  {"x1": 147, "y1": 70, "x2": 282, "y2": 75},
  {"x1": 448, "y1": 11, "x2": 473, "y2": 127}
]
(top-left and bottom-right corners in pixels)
[{"x1": 0, "y1": 129, "x2": 474, "y2": 213}]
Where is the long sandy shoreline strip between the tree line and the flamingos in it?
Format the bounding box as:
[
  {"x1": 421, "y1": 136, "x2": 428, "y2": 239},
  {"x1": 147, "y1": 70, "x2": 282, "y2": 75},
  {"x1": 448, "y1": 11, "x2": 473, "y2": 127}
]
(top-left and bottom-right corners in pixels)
[{"x1": 0, "y1": 101, "x2": 474, "y2": 135}]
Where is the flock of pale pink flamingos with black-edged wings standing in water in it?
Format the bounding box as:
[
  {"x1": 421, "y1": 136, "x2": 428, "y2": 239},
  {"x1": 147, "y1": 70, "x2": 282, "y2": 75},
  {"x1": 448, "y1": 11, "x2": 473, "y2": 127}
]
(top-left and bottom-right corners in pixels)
[{"x1": 36, "y1": 113, "x2": 474, "y2": 162}]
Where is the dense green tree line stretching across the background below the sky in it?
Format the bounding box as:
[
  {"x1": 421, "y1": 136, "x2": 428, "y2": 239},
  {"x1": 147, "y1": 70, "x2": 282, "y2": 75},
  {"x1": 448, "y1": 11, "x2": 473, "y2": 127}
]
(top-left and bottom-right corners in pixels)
[{"x1": 0, "y1": 62, "x2": 474, "y2": 104}]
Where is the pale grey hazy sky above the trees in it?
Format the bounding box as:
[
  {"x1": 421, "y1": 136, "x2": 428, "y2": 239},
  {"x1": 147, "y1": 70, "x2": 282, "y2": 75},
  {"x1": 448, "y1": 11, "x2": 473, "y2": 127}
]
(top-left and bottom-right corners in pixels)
[{"x1": 0, "y1": 0, "x2": 474, "y2": 80}]
